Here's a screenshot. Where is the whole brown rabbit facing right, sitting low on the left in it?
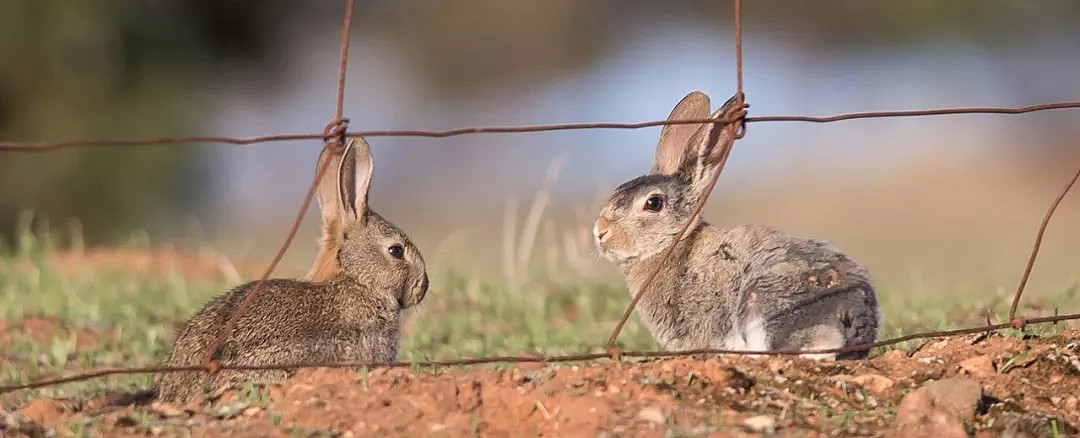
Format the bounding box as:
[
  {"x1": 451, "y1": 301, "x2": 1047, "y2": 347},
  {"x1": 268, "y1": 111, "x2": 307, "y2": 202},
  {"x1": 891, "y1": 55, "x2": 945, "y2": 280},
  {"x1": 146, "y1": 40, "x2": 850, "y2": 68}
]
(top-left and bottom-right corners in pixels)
[{"x1": 156, "y1": 138, "x2": 429, "y2": 402}]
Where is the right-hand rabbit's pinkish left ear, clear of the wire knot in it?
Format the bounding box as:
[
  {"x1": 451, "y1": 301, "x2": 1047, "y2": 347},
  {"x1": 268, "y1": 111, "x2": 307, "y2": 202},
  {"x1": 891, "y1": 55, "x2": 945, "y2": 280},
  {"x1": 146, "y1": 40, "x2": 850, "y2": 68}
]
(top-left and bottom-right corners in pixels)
[{"x1": 651, "y1": 92, "x2": 708, "y2": 175}]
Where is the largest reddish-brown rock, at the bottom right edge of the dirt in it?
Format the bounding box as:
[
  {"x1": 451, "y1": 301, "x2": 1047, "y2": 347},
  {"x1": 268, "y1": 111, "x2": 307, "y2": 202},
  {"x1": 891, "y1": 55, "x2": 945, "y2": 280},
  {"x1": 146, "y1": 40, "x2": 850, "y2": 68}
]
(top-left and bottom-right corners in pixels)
[{"x1": 895, "y1": 379, "x2": 983, "y2": 438}]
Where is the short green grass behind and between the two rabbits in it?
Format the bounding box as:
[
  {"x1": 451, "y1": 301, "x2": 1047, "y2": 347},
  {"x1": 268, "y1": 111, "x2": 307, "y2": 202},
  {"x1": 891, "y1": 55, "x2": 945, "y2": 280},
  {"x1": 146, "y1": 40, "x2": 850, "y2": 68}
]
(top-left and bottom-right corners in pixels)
[{"x1": 0, "y1": 222, "x2": 1077, "y2": 408}]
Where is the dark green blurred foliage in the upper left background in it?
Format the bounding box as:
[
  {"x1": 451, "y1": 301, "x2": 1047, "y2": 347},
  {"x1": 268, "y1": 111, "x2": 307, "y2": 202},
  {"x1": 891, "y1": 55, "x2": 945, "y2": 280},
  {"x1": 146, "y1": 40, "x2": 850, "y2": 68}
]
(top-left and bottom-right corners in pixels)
[{"x1": 0, "y1": 0, "x2": 294, "y2": 243}]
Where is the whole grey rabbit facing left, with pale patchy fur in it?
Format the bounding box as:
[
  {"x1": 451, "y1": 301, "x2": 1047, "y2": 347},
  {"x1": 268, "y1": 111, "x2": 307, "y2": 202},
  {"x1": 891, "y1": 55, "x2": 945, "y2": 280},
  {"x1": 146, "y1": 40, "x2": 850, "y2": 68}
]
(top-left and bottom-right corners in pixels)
[{"x1": 593, "y1": 92, "x2": 880, "y2": 358}]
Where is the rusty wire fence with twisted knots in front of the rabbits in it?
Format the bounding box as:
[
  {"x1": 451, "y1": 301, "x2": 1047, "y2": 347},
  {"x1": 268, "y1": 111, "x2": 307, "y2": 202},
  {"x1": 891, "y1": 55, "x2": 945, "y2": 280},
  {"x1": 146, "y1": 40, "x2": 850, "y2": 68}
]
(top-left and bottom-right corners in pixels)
[{"x1": 0, "y1": 0, "x2": 1080, "y2": 394}]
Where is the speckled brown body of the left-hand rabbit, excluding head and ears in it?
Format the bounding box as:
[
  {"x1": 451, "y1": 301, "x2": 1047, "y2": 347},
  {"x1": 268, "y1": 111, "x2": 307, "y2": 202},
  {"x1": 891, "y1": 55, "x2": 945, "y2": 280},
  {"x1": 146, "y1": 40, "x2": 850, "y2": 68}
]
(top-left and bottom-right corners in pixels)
[{"x1": 157, "y1": 277, "x2": 401, "y2": 402}]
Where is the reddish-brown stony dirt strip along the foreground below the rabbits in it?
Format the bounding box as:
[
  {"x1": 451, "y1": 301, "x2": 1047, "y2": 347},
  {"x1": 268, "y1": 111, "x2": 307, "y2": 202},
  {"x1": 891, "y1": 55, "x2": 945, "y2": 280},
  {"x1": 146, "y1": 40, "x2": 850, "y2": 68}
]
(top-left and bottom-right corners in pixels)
[{"x1": 0, "y1": 330, "x2": 1080, "y2": 438}]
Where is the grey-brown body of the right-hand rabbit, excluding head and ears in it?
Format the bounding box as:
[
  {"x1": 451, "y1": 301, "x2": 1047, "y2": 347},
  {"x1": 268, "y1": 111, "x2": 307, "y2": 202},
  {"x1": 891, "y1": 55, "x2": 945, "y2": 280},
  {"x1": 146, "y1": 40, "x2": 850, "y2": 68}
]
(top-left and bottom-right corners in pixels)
[{"x1": 623, "y1": 221, "x2": 879, "y2": 358}]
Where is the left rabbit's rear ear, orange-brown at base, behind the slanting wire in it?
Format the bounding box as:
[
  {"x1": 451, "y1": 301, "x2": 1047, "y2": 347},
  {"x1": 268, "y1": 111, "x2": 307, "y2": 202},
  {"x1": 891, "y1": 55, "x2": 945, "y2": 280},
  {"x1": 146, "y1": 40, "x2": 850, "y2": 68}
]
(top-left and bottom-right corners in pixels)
[{"x1": 306, "y1": 146, "x2": 345, "y2": 282}]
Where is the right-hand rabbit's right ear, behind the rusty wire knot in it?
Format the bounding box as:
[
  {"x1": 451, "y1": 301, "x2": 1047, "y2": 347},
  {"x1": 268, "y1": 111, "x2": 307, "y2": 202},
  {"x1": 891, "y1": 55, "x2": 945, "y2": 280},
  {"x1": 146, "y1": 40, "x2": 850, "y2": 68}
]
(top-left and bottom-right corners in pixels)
[{"x1": 680, "y1": 97, "x2": 739, "y2": 190}]
